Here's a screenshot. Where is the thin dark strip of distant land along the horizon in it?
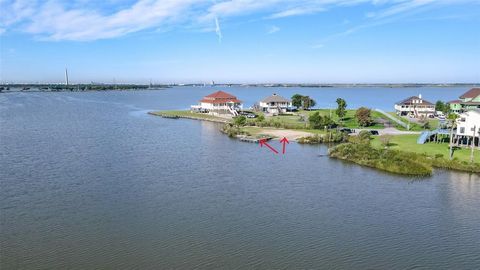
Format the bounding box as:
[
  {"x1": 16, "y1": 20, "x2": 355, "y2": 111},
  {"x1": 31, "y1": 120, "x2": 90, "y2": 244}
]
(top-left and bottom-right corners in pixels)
[{"x1": 0, "y1": 83, "x2": 480, "y2": 92}]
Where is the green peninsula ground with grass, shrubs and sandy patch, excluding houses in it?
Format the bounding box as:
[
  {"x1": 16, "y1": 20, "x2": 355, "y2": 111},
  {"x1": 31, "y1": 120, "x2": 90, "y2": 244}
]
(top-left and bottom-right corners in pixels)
[{"x1": 150, "y1": 95, "x2": 480, "y2": 176}]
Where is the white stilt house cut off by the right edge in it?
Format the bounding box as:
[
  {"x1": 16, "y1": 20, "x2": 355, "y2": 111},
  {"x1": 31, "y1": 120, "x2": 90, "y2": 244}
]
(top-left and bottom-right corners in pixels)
[{"x1": 456, "y1": 109, "x2": 480, "y2": 148}]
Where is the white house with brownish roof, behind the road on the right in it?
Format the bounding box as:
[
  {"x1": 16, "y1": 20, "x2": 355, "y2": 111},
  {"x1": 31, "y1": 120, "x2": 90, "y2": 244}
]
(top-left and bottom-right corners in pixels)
[{"x1": 395, "y1": 95, "x2": 435, "y2": 118}]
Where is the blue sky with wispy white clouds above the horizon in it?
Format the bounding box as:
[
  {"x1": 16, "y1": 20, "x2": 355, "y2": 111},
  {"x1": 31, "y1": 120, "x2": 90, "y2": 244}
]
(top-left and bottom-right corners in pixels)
[{"x1": 0, "y1": 0, "x2": 480, "y2": 83}]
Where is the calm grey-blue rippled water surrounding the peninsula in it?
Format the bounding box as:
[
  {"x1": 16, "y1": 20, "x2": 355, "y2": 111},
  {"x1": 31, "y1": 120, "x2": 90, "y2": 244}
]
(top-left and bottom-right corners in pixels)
[{"x1": 0, "y1": 88, "x2": 480, "y2": 270}]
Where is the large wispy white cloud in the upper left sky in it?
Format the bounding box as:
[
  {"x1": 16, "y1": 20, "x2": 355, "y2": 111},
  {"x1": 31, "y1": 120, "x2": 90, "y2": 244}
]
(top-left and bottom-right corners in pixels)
[{"x1": 1, "y1": 0, "x2": 198, "y2": 41}]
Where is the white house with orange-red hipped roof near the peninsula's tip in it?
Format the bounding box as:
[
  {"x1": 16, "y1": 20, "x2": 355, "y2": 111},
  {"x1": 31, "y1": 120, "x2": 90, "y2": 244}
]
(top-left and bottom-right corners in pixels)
[{"x1": 191, "y1": 91, "x2": 242, "y2": 117}]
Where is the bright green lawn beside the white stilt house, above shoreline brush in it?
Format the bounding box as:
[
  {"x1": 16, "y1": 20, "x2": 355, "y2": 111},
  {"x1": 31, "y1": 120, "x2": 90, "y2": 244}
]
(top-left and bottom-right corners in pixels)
[{"x1": 372, "y1": 135, "x2": 480, "y2": 163}]
